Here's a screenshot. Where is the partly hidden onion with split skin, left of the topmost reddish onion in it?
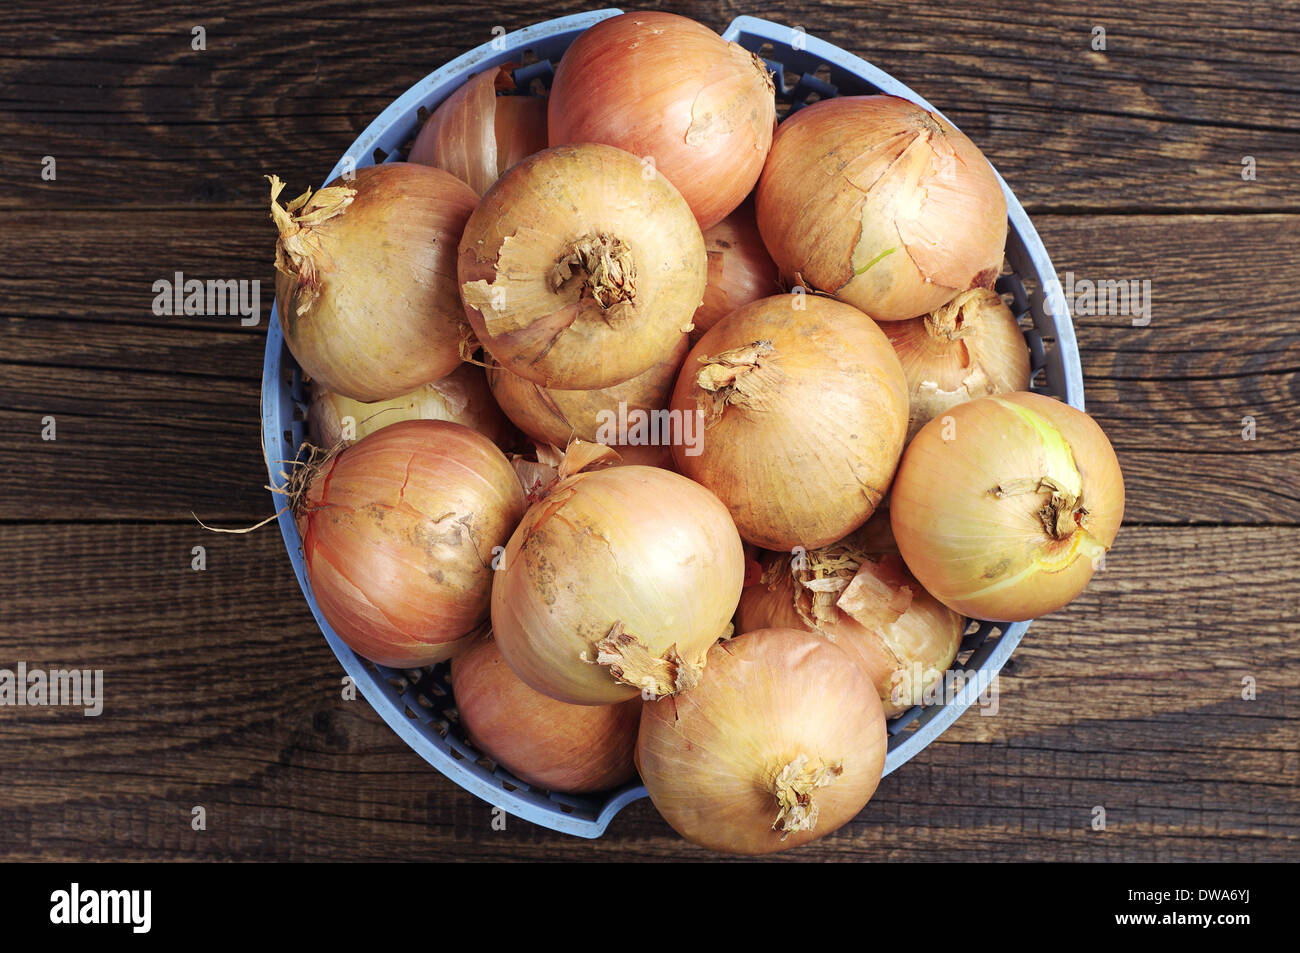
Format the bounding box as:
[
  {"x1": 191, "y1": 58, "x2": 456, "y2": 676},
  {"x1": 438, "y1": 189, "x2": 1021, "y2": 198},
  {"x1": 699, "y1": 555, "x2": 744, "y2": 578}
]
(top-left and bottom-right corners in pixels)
[{"x1": 408, "y1": 66, "x2": 546, "y2": 195}]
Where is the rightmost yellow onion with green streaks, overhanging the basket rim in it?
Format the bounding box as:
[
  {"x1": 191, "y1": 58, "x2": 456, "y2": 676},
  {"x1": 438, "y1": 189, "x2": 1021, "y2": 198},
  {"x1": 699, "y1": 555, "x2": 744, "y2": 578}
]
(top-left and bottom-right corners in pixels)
[{"x1": 889, "y1": 393, "x2": 1125, "y2": 621}]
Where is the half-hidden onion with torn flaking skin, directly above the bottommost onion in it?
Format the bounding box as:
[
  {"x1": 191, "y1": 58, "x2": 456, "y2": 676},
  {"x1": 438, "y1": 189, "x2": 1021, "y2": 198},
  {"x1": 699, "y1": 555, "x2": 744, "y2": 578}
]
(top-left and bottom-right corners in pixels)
[{"x1": 736, "y1": 535, "x2": 966, "y2": 718}]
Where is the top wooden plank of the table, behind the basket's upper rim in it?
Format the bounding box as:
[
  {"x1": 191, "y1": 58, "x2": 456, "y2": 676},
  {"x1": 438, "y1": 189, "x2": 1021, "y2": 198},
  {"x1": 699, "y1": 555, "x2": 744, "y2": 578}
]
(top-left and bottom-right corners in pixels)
[{"x1": 0, "y1": 0, "x2": 1300, "y2": 212}]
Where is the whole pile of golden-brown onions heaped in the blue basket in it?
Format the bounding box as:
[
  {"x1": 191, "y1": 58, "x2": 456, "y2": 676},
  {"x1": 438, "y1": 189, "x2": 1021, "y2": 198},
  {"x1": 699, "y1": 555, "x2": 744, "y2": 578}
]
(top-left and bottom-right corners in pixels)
[{"x1": 261, "y1": 12, "x2": 1125, "y2": 854}]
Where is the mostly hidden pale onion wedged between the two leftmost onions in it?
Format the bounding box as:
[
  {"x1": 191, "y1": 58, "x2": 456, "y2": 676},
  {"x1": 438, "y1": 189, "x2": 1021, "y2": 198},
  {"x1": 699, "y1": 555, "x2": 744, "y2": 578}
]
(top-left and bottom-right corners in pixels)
[{"x1": 307, "y1": 364, "x2": 514, "y2": 447}]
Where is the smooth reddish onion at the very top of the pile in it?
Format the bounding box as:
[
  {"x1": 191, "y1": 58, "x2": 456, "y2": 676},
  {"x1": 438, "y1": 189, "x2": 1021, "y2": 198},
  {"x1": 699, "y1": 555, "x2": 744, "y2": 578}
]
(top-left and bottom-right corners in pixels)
[{"x1": 547, "y1": 12, "x2": 776, "y2": 229}]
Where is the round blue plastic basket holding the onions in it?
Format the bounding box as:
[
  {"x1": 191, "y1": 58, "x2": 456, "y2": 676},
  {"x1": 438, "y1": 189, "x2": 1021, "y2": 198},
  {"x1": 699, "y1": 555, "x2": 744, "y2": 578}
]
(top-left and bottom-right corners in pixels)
[{"x1": 261, "y1": 9, "x2": 1083, "y2": 837}]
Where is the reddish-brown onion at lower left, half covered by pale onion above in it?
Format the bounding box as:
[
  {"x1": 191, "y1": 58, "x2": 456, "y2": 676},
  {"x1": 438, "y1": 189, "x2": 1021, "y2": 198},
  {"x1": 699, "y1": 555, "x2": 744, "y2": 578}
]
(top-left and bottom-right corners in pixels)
[{"x1": 451, "y1": 638, "x2": 641, "y2": 793}]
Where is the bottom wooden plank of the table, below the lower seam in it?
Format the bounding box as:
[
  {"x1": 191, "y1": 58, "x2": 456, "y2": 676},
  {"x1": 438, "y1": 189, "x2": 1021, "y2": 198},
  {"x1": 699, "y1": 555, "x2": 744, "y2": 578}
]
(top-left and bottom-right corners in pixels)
[{"x1": 0, "y1": 524, "x2": 1300, "y2": 861}]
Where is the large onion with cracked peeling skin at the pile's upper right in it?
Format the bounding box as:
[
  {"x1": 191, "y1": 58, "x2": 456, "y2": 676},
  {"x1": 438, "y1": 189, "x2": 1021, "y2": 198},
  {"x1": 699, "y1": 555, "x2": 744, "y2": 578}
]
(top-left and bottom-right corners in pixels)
[{"x1": 755, "y1": 96, "x2": 1006, "y2": 321}]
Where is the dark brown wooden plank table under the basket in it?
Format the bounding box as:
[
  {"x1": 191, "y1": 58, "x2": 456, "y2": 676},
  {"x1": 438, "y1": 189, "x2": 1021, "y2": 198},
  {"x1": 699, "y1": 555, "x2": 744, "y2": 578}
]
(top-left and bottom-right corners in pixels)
[{"x1": 0, "y1": 0, "x2": 1300, "y2": 861}]
